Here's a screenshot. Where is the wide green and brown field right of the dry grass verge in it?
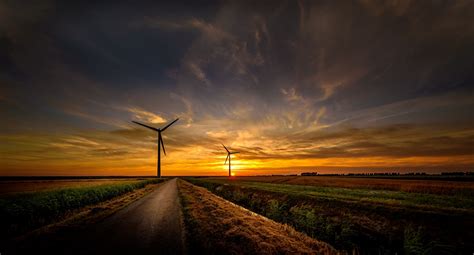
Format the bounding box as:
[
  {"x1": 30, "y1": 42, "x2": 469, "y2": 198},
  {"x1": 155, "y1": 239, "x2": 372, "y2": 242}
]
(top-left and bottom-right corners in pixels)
[{"x1": 187, "y1": 177, "x2": 474, "y2": 254}]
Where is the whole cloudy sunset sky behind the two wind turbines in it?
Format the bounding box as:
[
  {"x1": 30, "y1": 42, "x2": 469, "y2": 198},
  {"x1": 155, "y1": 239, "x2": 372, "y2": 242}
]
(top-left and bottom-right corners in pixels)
[{"x1": 0, "y1": 0, "x2": 474, "y2": 176}]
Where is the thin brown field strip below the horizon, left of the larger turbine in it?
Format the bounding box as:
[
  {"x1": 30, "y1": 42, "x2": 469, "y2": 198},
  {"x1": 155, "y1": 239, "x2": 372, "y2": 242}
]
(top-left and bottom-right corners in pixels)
[{"x1": 0, "y1": 178, "x2": 143, "y2": 195}]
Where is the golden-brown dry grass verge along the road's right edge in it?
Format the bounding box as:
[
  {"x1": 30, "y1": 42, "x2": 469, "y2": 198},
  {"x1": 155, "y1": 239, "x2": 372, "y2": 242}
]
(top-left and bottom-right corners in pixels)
[{"x1": 178, "y1": 180, "x2": 337, "y2": 254}]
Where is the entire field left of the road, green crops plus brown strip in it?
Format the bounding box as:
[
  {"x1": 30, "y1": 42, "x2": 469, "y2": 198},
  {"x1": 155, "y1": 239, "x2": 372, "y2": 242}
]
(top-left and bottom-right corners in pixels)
[{"x1": 0, "y1": 178, "x2": 163, "y2": 239}]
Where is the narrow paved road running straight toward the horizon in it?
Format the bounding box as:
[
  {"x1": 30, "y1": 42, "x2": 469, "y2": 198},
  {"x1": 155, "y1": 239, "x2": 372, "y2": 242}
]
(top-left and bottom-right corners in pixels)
[{"x1": 5, "y1": 179, "x2": 185, "y2": 254}]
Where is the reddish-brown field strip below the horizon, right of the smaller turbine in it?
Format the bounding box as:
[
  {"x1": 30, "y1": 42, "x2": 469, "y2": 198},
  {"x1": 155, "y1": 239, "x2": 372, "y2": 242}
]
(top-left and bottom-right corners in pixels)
[{"x1": 215, "y1": 176, "x2": 474, "y2": 195}]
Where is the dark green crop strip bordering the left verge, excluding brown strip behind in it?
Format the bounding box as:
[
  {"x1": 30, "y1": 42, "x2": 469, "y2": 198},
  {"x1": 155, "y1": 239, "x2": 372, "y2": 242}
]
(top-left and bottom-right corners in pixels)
[{"x1": 0, "y1": 179, "x2": 163, "y2": 239}]
